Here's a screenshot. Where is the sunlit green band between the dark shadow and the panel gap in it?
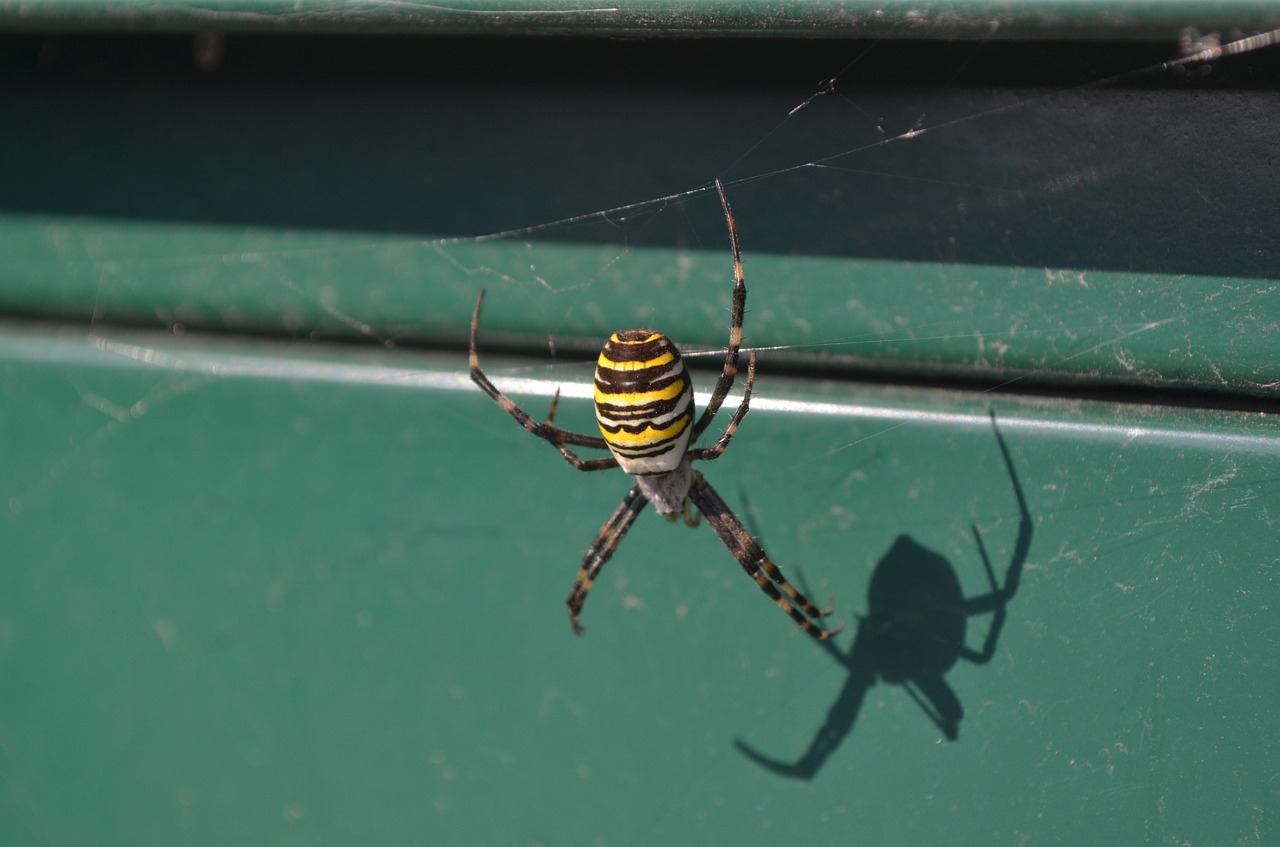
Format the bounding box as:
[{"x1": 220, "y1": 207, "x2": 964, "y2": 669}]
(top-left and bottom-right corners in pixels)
[{"x1": 6, "y1": 212, "x2": 1280, "y2": 394}]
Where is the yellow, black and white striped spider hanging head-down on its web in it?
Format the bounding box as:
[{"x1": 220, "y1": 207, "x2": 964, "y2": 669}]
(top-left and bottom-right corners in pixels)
[{"x1": 470, "y1": 179, "x2": 840, "y2": 638}]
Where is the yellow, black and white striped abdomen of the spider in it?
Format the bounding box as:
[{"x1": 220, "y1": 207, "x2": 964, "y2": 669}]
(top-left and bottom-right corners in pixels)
[{"x1": 595, "y1": 329, "x2": 694, "y2": 473}]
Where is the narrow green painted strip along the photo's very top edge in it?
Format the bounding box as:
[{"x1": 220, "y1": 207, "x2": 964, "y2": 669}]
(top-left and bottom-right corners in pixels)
[{"x1": 0, "y1": 0, "x2": 1280, "y2": 38}]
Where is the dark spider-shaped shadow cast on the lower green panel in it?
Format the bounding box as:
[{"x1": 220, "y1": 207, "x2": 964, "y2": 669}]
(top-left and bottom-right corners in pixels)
[{"x1": 733, "y1": 413, "x2": 1032, "y2": 779}]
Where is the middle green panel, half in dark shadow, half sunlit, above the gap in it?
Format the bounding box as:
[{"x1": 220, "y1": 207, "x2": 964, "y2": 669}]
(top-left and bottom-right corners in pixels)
[{"x1": 0, "y1": 30, "x2": 1280, "y2": 397}]
